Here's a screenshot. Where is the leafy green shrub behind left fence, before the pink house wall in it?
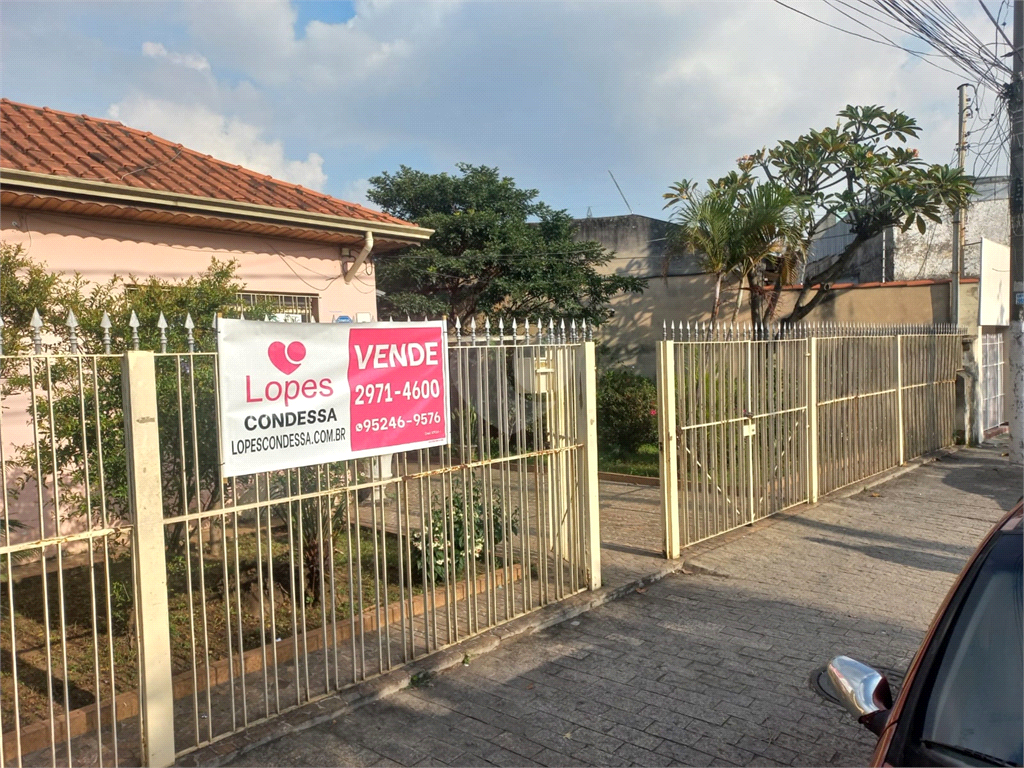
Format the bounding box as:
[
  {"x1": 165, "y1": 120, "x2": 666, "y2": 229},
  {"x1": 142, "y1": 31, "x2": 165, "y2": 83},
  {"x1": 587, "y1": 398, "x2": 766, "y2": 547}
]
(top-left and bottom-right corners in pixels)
[{"x1": 0, "y1": 244, "x2": 271, "y2": 551}]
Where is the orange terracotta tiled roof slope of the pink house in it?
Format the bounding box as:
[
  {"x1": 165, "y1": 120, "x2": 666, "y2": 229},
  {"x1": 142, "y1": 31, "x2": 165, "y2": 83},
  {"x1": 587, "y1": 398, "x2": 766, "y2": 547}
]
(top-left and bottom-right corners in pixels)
[{"x1": 0, "y1": 98, "x2": 410, "y2": 225}]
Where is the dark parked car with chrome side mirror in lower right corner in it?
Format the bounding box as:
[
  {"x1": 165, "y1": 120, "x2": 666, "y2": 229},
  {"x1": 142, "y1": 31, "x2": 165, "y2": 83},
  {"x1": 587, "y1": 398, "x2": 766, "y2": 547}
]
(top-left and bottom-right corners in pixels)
[{"x1": 822, "y1": 504, "x2": 1024, "y2": 766}]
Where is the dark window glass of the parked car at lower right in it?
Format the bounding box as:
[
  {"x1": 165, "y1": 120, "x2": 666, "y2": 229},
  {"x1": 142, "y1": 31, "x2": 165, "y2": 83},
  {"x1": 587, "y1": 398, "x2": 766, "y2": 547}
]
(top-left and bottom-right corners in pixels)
[{"x1": 916, "y1": 534, "x2": 1024, "y2": 765}]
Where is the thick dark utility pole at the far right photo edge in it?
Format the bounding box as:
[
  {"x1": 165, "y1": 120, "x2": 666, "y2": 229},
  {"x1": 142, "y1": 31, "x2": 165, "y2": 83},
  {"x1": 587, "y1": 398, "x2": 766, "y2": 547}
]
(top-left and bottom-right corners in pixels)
[{"x1": 1007, "y1": 0, "x2": 1024, "y2": 462}]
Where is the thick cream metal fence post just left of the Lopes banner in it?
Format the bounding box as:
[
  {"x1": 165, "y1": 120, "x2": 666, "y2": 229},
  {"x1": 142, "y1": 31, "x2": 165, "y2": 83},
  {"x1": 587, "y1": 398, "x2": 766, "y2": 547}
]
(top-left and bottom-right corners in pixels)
[{"x1": 121, "y1": 352, "x2": 174, "y2": 768}]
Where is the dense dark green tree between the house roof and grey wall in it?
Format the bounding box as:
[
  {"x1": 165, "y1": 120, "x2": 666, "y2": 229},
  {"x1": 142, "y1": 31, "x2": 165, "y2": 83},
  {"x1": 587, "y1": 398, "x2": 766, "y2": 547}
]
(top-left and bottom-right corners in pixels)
[{"x1": 367, "y1": 164, "x2": 646, "y2": 325}]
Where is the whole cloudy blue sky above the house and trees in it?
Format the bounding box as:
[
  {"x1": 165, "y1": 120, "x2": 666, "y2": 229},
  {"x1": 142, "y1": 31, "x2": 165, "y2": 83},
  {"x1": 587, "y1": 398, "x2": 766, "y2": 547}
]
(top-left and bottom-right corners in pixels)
[{"x1": 0, "y1": 0, "x2": 999, "y2": 222}]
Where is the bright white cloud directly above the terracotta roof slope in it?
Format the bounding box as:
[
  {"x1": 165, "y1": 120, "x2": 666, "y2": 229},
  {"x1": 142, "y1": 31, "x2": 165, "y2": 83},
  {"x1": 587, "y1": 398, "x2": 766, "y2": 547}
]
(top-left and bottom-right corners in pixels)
[{"x1": 108, "y1": 95, "x2": 327, "y2": 189}]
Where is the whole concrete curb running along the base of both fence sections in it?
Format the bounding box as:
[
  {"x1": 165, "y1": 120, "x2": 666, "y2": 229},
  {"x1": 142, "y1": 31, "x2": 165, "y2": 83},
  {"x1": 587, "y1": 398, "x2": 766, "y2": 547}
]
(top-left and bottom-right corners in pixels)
[{"x1": 175, "y1": 446, "x2": 959, "y2": 767}]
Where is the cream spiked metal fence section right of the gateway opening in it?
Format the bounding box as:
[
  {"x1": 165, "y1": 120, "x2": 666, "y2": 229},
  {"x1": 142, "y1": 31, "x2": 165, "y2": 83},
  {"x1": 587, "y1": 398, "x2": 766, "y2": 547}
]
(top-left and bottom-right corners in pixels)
[{"x1": 657, "y1": 326, "x2": 962, "y2": 557}]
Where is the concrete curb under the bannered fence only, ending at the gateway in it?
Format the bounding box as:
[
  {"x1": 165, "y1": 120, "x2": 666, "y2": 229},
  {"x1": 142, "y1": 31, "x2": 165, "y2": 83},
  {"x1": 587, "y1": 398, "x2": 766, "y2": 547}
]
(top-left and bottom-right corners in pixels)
[{"x1": 175, "y1": 560, "x2": 684, "y2": 766}]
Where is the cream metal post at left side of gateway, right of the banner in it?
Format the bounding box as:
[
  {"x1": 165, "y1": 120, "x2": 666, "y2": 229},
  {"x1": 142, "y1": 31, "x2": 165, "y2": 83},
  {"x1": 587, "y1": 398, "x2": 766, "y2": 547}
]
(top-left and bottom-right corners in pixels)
[{"x1": 577, "y1": 341, "x2": 601, "y2": 590}]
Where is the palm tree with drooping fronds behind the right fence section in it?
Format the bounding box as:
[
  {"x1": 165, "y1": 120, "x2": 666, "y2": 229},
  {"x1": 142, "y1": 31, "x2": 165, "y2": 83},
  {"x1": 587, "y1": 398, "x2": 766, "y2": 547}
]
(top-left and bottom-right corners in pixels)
[{"x1": 663, "y1": 177, "x2": 802, "y2": 323}]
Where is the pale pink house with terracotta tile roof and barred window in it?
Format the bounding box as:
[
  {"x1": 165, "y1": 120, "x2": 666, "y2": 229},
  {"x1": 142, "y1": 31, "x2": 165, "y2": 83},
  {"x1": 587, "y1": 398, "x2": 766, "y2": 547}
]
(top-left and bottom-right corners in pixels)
[{"x1": 0, "y1": 99, "x2": 431, "y2": 323}]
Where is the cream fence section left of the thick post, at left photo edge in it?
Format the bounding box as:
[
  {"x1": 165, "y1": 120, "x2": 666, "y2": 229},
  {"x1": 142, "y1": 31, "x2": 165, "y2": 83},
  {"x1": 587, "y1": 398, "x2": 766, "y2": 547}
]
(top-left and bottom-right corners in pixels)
[{"x1": 0, "y1": 354, "x2": 141, "y2": 765}]
